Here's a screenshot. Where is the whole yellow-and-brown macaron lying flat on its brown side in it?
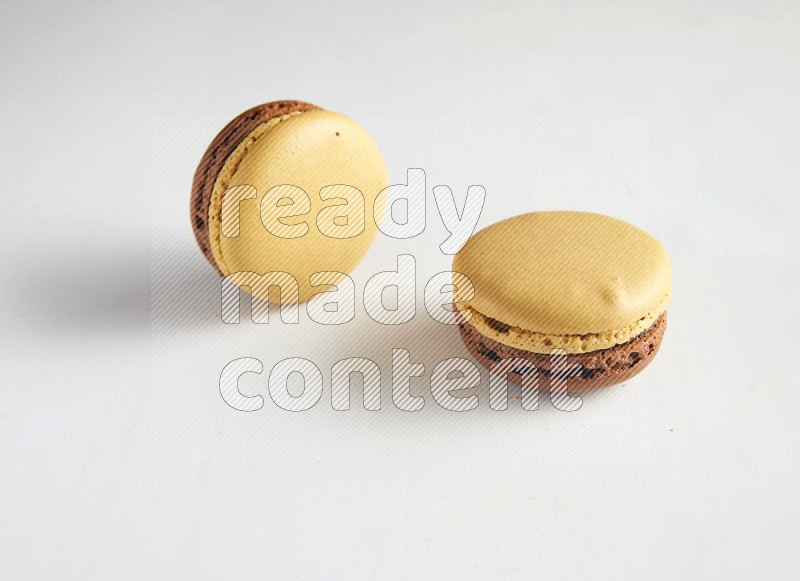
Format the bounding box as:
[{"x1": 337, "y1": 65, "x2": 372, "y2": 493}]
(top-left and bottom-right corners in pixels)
[{"x1": 453, "y1": 211, "x2": 672, "y2": 392}]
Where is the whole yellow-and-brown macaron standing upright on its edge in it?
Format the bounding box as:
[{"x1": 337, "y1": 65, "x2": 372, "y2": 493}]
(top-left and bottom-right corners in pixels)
[{"x1": 190, "y1": 101, "x2": 388, "y2": 302}]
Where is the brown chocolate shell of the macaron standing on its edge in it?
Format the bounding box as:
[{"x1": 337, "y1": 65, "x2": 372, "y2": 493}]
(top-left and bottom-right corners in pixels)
[{"x1": 191, "y1": 101, "x2": 319, "y2": 275}]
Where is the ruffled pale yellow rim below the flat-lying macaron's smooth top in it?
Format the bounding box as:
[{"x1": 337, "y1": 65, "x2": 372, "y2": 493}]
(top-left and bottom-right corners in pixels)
[{"x1": 459, "y1": 288, "x2": 672, "y2": 354}]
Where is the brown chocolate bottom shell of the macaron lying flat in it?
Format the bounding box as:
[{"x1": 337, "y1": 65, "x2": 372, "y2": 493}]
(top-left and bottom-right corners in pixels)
[{"x1": 459, "y1": 313, "x2": 667, "y2": 392}]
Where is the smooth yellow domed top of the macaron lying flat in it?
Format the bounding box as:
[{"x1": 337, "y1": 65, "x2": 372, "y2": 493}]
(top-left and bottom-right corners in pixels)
[{"x1": 453, "y1": 212, "x2": 672, "y2": 338}]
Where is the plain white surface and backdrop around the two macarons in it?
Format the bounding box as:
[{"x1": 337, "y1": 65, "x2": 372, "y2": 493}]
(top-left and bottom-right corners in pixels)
[{"x1": 0, "y1": 1, "x2": 800, "y2": 579}]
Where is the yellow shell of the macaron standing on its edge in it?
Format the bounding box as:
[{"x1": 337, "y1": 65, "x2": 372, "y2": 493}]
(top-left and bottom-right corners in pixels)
[{"x1": 209, "y1": 110, "x2": 388, "y2": 301}]
